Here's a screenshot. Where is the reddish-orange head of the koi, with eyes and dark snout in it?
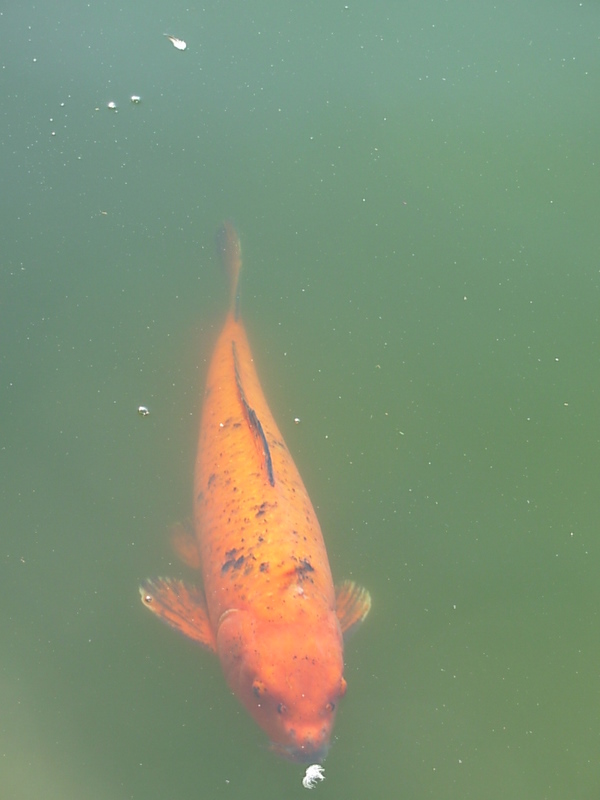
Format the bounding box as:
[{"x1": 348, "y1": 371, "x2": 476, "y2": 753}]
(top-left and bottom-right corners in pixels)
[{"x1": 217, "y1": 610, "x2": 346, "y2": 763}]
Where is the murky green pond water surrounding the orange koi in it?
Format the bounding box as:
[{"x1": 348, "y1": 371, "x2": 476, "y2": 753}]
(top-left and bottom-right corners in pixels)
[{"x1": 0, "y1": 0, "x2": 600, "y2": 800}]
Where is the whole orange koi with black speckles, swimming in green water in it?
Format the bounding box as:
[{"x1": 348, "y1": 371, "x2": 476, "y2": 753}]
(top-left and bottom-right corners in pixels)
[{"x1": 140, "y1": 222, "x2": 371, "y2": 762}]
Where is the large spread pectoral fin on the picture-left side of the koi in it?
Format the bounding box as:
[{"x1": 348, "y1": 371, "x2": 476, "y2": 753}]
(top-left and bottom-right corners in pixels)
[{"x1": 140, "y1": 578, "x2": 217, "y2": 652}]
